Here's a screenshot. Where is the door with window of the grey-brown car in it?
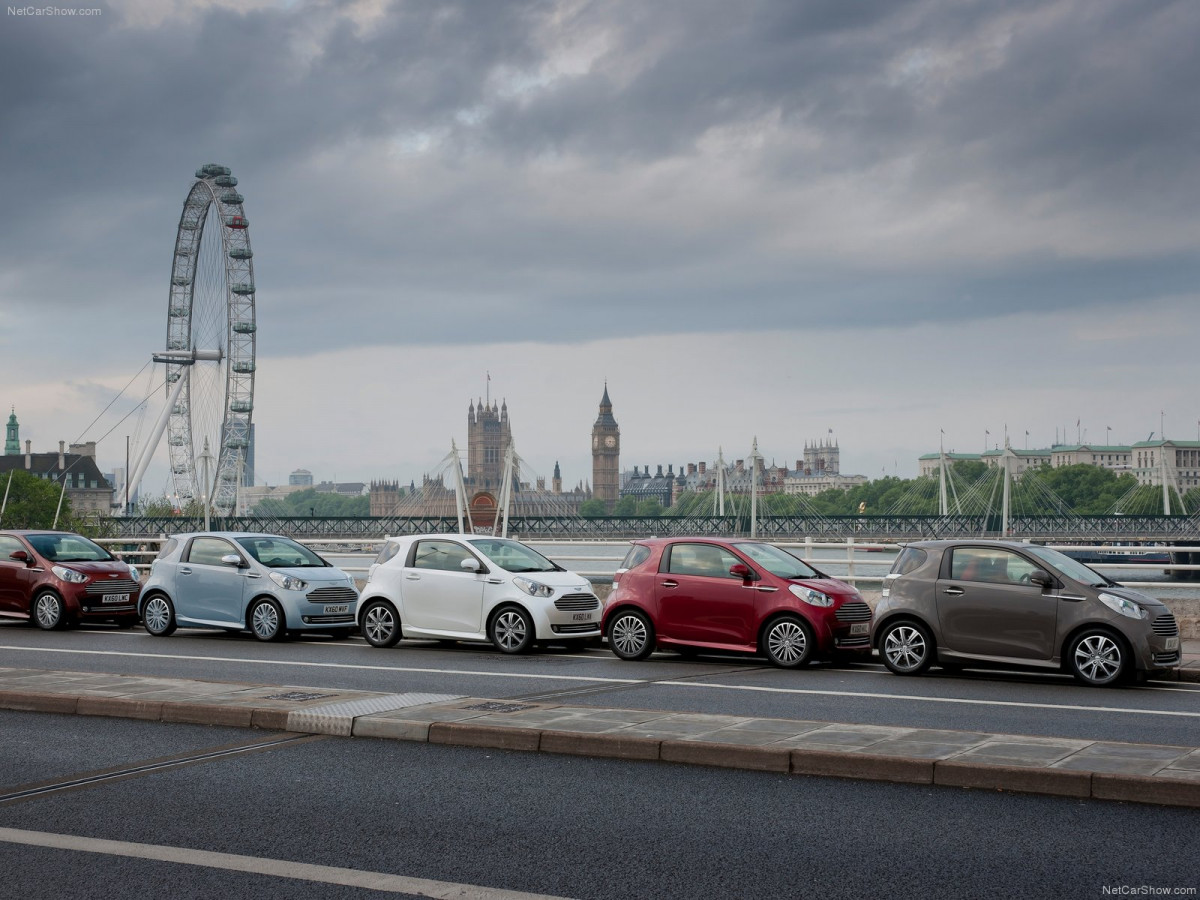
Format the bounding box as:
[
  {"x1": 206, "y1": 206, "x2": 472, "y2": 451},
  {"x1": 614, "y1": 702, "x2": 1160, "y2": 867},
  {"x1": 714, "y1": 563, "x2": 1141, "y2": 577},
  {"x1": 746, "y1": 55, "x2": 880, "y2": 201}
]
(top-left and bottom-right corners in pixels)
[{"x1": 936, "y1": 547, "x2": 1058, "y2": 660}]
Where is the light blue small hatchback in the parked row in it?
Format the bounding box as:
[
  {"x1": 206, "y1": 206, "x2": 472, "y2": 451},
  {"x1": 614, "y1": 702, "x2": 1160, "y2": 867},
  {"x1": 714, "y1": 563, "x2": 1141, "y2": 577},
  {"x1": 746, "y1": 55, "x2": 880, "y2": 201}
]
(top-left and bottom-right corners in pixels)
[{"x1": 138, "y1": 532, "x2": 359, "y2": 641}]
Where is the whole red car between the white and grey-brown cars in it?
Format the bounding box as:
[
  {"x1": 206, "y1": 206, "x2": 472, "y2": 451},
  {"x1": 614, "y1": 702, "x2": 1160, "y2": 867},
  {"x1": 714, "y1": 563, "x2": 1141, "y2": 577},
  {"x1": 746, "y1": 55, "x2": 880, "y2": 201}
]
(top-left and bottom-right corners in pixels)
[{"x1": 604, "y1": 538, "x2": 871, "y2": 668}]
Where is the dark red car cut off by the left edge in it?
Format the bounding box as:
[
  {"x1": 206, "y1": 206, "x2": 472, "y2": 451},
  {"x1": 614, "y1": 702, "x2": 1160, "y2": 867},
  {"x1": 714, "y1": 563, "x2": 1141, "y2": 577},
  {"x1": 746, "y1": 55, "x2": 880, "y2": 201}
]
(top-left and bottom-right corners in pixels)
[{"x1": 0, "y1": 532, "x2": 142, "y2": 630}]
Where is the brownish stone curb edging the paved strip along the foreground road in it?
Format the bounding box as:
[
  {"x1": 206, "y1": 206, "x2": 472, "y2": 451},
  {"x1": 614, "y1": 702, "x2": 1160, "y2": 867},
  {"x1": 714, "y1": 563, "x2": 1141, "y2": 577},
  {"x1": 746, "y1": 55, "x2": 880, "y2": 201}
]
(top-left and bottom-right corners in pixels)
[{"x1": 0, "y1": 691, "x2": 1200, "y2": 809}]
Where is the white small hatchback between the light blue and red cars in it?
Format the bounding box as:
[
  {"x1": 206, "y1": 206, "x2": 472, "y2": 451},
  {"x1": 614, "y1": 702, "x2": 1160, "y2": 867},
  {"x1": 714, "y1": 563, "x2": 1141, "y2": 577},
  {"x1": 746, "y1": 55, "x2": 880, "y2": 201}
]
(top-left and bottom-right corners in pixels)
[{"x1": 358, "y1": 534, "x2": 600, "y2": 653}]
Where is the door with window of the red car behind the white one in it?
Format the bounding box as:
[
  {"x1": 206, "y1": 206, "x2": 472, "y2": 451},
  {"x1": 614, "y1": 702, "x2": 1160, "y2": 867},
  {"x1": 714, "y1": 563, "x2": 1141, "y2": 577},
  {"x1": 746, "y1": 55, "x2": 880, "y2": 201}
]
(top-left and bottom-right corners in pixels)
[{"x1": 654, "y1": 542, "x2": 756, "y2": 646}]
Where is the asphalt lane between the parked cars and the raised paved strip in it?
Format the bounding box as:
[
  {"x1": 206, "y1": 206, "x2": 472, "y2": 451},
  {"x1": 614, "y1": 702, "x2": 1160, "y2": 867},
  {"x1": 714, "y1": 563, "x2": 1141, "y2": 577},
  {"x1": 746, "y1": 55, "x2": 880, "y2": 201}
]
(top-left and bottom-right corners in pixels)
[{"x1": 0, "y1": 623, "x2": 1200, "y2": 746}]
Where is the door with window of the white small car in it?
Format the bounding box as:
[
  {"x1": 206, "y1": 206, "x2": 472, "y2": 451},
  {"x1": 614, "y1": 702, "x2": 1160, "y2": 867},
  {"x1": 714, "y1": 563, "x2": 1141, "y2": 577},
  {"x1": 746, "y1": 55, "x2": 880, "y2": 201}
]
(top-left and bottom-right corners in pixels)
[{"x1": 401, "y1": 539, "x2": 484, "y2": 635}]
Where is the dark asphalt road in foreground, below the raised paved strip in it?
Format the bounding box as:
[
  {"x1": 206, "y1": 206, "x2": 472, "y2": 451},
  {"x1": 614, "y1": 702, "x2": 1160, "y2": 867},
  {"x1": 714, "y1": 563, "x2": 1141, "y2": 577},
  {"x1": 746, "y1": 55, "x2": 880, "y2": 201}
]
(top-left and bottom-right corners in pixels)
[{"x1": 0, "y1": 712, "x2": 1200, "y2": 900}]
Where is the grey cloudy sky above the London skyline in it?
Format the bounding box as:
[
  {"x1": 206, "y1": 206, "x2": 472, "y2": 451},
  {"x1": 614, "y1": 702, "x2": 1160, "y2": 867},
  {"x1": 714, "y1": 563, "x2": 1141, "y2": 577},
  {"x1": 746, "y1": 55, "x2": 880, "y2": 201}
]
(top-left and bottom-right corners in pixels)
[{"x1": 0, "y1": 0, "x2": 1200, "y2": 493}]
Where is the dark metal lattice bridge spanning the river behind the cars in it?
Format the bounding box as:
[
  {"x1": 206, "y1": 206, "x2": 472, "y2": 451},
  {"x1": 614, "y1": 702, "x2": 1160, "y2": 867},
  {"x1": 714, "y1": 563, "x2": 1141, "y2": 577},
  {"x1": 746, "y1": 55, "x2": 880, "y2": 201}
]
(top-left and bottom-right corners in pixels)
[{"x1": 106, "y1": 514, "x2": 1200, "y2": 544}]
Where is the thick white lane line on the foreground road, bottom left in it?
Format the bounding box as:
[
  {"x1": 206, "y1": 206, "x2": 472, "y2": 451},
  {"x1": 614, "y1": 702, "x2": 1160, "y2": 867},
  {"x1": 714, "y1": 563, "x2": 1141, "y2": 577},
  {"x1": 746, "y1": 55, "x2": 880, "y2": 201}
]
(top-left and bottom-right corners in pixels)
[{"x1": 0, "y1": 828, "x2": 564, "y2": 900}]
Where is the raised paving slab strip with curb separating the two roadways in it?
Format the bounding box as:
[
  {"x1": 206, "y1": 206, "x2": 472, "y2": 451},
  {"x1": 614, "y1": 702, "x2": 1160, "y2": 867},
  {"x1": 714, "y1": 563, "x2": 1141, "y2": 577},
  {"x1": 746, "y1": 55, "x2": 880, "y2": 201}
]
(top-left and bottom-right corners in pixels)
[{"x1": 0, "y1": 668, "x2": 1200, "y2": 808}]
